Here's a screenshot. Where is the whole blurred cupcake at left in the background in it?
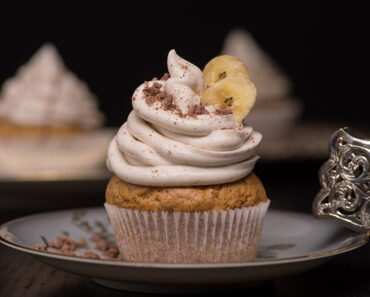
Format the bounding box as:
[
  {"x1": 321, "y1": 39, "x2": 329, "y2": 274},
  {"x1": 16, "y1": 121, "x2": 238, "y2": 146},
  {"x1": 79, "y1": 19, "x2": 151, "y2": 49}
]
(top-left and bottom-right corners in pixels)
[{"x1": 0, "y1": 44, "x2": 112, "y2": 174}]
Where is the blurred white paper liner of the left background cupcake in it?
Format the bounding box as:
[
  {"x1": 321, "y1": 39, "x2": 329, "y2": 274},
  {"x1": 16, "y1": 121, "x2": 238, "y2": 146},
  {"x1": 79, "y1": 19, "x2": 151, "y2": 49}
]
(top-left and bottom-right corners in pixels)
[{"x1": 0, "y1": 129, "x2": 114, "y2": 174}]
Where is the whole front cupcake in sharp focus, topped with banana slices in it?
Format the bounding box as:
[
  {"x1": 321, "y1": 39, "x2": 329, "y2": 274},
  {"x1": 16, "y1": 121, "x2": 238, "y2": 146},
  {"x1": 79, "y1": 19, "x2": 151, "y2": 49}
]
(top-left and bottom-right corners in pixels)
[{"x1": 105, "y1": 50, "x2": 269, "y2": 263}]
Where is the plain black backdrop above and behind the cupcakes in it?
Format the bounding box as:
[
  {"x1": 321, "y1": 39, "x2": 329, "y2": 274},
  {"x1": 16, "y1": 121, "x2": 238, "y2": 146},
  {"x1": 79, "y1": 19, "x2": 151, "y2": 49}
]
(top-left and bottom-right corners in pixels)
[{"x1": 0, "y1": 1, "x2": 370, "y2": 126}]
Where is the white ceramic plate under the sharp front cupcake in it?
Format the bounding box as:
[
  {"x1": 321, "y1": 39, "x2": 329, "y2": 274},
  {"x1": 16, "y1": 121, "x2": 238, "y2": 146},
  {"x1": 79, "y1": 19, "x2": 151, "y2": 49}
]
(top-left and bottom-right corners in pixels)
[{"x1": 0, "y1": 207, "x2": 368, "y2": 293}]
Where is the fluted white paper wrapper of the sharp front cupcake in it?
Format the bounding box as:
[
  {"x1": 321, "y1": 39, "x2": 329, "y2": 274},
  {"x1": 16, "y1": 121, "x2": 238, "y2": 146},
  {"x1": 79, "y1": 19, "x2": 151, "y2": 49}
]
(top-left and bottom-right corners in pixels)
[{"x1": 105, "y1": 200, "x2": 270, "y2": 263}]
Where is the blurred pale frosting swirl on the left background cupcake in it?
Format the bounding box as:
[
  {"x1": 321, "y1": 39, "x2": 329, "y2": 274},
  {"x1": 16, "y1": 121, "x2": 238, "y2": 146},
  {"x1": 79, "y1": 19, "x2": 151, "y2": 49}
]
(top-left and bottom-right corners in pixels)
[{"x1": 0, "y1": 44, "x2": 103, "y2": 129}]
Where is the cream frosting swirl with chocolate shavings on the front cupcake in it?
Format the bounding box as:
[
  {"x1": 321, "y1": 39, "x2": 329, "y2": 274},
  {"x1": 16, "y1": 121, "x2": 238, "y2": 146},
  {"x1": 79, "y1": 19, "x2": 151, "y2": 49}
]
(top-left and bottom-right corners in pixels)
[{"x1": 107, "y1": 50, "x2": 262, "y2": 186}]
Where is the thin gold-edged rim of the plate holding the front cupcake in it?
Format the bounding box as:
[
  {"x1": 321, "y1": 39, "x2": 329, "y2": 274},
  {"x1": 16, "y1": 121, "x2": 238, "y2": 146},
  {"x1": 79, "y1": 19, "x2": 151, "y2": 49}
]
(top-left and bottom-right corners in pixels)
[{"x1": 0, "y1": 207, "x2": 370, "y2": 269}]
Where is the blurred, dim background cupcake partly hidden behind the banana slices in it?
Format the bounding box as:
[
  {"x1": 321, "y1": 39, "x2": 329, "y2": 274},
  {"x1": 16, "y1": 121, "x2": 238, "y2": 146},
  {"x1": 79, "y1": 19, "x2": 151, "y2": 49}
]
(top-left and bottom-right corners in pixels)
[{"x1": 222, "y1": 29, "x2": 302, "y2": 140}]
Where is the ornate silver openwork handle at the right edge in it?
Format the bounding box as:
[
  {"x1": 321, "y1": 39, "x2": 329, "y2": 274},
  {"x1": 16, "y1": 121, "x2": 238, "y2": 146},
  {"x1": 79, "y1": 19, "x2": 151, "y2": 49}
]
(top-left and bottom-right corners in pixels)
[{"x1": 312, "y1": 128, "x2": 370, "y2": 232}]
